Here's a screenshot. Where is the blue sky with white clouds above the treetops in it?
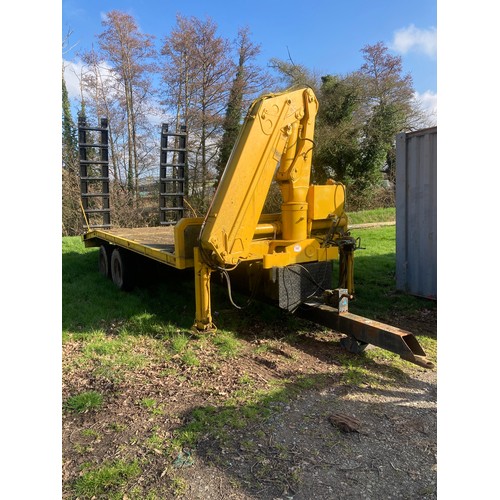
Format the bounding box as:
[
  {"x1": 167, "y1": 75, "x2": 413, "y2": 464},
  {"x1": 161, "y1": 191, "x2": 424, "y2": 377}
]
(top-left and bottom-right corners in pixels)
[{"x1": 61, "y1": 0, "x2": 437, "y2": 117}]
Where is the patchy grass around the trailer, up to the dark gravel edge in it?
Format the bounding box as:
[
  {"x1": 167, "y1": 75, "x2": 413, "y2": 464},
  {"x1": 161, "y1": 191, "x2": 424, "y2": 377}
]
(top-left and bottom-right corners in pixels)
[{"x1": 62, "y1": 212, "x2": 436, "y2": 499}]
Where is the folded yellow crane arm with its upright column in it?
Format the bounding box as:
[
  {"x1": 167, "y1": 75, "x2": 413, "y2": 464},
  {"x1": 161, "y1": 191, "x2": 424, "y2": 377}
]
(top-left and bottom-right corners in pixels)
[{"x1": 200, "y1": 89, "x2": 318, "y2": 266}]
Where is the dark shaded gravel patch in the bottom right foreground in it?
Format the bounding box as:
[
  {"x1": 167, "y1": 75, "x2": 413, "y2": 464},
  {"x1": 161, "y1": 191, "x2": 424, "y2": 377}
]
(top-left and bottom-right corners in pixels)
[{"x1": 64, "y1": 364, "x2": 436, "y2": 500}]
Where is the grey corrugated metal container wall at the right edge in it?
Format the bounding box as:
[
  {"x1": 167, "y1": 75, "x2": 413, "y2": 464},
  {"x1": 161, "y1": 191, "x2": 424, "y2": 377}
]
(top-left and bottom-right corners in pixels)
[{"x1": 396, "y1": 127, "x2": 437, "y2": 298}]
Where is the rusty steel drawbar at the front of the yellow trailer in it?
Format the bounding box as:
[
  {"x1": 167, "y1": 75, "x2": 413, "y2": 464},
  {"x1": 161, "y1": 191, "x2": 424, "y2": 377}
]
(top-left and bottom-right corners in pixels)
[{"x1": 295, "y1": 289, "x2": 434, "y2": 368}]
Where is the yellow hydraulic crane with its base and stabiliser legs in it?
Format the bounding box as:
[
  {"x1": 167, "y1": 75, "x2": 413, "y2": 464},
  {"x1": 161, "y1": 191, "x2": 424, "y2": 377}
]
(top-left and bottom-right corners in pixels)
[{"x1": 194, "y1": 88, "x2": 354, "y2": 330}]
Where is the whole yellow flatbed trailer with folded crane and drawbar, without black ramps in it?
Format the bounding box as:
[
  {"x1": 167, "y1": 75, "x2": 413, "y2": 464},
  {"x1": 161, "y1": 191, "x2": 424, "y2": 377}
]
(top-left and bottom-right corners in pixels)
[{"x1": 82, "y1": 88, "x2": 432, "y2": 368}]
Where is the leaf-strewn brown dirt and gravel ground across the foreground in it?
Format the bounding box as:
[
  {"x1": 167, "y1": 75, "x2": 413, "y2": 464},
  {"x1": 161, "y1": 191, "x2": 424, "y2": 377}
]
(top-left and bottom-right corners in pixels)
[{"x1": 62, "y1": 311, "x2": 437, "y2": 500}]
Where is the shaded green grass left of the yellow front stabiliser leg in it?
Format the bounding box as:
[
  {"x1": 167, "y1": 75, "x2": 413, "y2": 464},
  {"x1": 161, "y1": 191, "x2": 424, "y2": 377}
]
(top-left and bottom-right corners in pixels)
[{"x1": 62, "y1": 236, "x2": 194, "y2": 340}]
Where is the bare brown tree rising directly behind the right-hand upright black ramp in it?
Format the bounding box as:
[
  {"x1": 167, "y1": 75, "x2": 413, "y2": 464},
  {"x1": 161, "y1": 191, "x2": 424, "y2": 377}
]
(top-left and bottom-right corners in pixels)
[{"x1": 162, "y1": 15, "x2": 234, "y2": 211}]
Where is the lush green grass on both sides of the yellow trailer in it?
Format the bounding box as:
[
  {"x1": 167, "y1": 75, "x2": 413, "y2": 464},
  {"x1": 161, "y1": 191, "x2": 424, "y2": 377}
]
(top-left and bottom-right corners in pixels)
[{"x1": 62, "y1": 208, "x2": 436, "y2": 352}]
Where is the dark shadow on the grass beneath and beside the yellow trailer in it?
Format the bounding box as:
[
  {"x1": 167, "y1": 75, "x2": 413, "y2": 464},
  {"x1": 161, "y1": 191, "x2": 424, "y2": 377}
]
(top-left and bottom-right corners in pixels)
[{"x1": 62, "y1": 245, "x2": 436, "y2": 361}]
